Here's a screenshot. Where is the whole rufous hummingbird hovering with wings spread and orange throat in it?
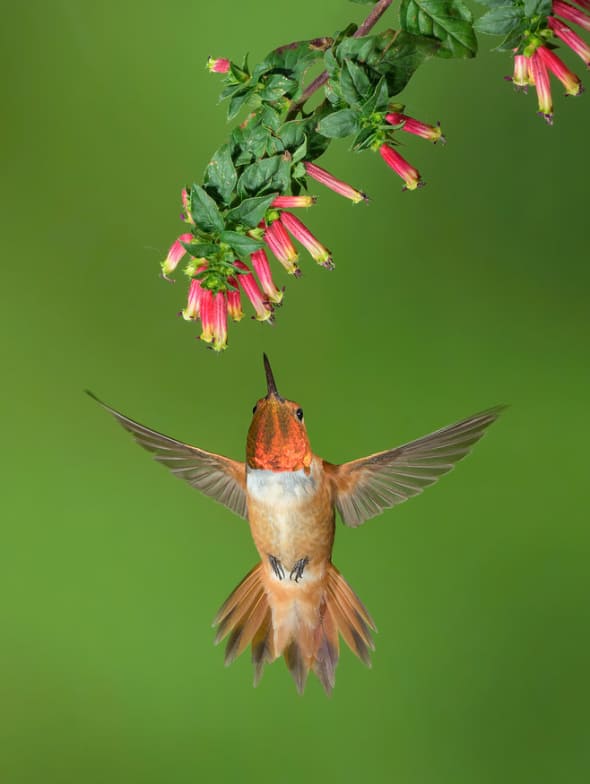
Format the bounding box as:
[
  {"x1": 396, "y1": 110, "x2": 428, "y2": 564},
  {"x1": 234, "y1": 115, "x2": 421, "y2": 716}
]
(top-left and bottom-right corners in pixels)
[{"x1": 88, "y1": 354, "x2": 504, "y2": 694}]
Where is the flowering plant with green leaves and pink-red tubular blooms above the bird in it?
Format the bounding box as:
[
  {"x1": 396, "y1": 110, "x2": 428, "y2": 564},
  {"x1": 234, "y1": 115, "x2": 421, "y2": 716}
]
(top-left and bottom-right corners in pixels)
[{"x1": 162, "y1": 0, "x2": 590, "y2": 351}]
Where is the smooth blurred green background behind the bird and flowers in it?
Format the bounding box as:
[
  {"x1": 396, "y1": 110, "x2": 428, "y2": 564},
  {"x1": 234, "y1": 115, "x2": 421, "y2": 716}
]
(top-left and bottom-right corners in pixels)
[{"x1": 0, "y1": 0, "x2": 590, "y2": 784}]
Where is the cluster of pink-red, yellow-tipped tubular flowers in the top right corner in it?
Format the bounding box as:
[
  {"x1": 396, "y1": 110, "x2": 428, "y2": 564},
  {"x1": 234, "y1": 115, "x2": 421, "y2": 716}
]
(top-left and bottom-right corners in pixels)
[{"x1": 506, "y1": 0, "x2": 590, "y2": 125}]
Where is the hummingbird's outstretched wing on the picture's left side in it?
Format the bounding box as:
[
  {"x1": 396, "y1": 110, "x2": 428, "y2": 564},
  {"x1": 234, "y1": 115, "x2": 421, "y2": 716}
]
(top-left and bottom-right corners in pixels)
[{"x1": 88, "y1": 392, "x2": 246, "y2": 517}]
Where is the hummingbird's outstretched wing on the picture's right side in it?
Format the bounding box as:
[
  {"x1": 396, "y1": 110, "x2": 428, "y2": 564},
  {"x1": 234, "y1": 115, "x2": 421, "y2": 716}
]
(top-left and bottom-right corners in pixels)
[{"x1": 324, "y1": 406, "x2": 505, "y2": 528}]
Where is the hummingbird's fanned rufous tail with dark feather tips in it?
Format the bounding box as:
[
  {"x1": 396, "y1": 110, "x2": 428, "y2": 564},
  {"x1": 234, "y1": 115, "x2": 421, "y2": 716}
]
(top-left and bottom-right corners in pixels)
[{"x1": 214, "y1": 564, "x2": 377, "y2": 694}]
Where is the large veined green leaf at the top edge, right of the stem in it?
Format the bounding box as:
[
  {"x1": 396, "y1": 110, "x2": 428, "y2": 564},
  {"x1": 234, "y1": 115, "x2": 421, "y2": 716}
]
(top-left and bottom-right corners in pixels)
[{"x1": 399, "y1": 0, "x2": 477, "y2": 57}]
